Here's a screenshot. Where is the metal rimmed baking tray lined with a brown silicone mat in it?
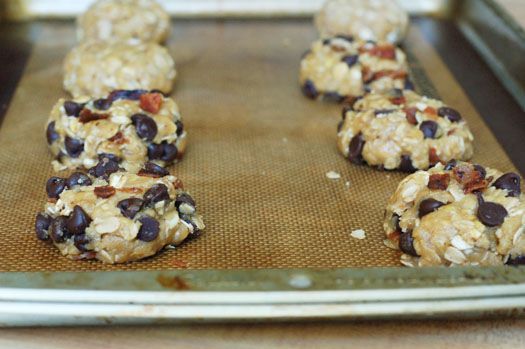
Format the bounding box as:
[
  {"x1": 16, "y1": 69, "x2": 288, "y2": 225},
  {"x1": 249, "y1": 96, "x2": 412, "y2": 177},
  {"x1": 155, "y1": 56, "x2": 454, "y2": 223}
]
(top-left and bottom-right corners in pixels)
[{"x1": 0, "y1": 0, "x2": 525, "y2": 326}]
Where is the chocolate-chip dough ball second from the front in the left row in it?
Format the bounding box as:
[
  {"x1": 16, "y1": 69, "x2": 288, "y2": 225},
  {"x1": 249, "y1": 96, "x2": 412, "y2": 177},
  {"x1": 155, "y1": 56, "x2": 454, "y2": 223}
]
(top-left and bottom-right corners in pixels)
[{"x1": 46, "y1": 90, "x2": 187, "y2": 172}]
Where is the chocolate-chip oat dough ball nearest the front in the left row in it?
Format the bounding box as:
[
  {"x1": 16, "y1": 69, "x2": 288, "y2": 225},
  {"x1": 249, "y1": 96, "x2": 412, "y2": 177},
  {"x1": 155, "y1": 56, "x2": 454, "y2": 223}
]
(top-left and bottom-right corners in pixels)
[{"x1": 35, "y1": 164, "x2": 204, "y2": 263}]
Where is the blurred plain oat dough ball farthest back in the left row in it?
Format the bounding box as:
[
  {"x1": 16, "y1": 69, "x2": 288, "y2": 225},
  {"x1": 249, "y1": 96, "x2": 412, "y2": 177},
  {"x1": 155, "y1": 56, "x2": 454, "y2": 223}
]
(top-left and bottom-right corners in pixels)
[{"x1": 77, "y1": 0, "x2": 170, "y2": 43}]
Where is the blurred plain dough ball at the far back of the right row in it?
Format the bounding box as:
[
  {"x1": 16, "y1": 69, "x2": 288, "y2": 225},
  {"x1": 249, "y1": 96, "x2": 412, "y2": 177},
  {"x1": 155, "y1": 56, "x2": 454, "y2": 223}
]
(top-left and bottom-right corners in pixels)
[{"x1": 315, "y1": 0, "x2": 408, "y2": 44}]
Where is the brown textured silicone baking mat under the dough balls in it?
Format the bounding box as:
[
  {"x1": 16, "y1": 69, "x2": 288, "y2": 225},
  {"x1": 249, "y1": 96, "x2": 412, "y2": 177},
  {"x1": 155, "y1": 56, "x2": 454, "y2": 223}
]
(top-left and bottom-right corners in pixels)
[{"x1": 0, "y1": 20, "x2": 513, "y2": 271}]
